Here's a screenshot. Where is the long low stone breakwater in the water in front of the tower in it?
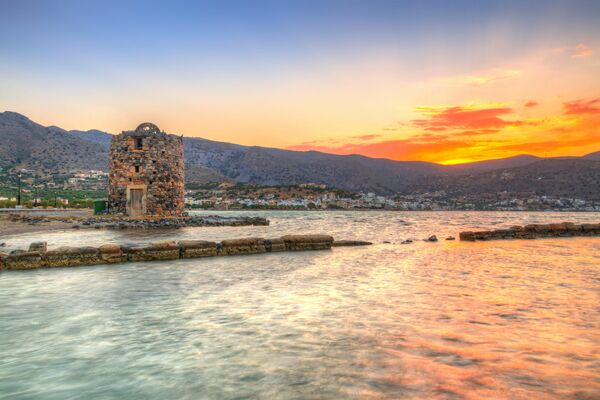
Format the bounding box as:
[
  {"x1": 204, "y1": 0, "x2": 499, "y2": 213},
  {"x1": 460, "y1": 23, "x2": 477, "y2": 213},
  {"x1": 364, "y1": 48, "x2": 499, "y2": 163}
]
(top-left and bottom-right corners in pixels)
[{"x1": 0, "y1": 235, "x2": 364, "y2": 270}]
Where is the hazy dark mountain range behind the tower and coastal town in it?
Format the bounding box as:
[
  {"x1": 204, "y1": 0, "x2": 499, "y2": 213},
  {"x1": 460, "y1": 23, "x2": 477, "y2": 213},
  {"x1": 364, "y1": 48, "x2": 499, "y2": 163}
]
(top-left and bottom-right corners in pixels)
[{"x1": 0, "y1": 111, "x2": 600, "y2": 198}]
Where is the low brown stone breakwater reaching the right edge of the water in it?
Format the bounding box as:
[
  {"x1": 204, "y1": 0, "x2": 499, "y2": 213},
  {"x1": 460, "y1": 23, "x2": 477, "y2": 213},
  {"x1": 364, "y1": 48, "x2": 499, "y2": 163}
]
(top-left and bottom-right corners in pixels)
[{"x1": 460, "y1": 222, "x2": 600, "y2": 242}]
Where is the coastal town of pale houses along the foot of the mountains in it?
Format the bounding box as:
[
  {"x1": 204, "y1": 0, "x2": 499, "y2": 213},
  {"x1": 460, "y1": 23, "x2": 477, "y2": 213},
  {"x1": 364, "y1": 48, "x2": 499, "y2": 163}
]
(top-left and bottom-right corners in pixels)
[{"x1": 0, "y1": 170, "x2": 600, "y2": 212}]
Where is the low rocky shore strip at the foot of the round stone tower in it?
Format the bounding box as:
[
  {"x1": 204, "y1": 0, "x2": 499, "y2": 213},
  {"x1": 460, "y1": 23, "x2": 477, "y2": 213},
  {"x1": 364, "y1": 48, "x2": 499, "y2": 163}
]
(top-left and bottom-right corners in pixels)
[{"x1": 11, "y1": 214, "x2": 269, "y2": 229}]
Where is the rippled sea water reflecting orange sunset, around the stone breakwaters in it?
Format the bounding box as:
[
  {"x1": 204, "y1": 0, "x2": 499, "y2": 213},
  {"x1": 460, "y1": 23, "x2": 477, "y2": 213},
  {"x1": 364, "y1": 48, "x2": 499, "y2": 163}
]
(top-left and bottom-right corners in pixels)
[{"x1": 0, "y1": 212, "x2": 600, "y2": 400}]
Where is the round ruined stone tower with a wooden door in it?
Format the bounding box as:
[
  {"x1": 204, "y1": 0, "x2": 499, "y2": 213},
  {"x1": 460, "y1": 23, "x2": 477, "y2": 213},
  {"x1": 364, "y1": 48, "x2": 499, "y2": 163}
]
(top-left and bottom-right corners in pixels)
[{"x1": 108, "y1": 122, "x2": 184, "y2": 217}]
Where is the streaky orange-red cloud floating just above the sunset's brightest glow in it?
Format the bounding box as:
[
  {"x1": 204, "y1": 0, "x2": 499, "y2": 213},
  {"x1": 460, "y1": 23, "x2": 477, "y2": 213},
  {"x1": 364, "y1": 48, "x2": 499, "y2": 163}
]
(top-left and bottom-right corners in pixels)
[{"x1": 412, "y1": 106, "x2": 522, "y2": 131}]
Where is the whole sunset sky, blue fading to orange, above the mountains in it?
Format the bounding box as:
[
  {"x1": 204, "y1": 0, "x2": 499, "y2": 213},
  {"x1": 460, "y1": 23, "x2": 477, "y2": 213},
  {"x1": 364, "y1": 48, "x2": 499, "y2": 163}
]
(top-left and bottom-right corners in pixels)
[{"x1": 0, "y1": 1, "x2": 600, "y2": 164}]
